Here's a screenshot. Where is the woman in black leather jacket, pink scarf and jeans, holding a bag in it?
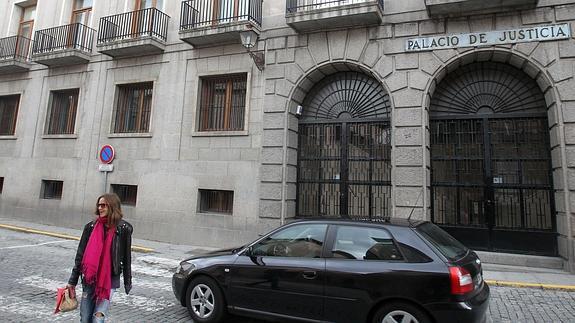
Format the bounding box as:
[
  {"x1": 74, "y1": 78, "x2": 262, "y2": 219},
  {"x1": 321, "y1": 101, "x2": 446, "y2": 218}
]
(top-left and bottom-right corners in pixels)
[{"x1": 68, "y1": 194, "x2": 133, "y2": 323}]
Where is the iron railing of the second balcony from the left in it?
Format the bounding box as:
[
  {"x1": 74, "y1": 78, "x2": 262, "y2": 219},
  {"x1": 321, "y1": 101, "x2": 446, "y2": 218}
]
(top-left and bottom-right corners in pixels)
[{"x1": 32, "y1": 23, "x2": 95, "y2": 54}]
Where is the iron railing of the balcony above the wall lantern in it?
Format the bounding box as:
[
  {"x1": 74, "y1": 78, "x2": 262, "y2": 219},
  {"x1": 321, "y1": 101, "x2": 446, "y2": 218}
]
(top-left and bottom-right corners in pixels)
[{"x1": 180, "y1": 0, "x2": 263, "y2": 30}]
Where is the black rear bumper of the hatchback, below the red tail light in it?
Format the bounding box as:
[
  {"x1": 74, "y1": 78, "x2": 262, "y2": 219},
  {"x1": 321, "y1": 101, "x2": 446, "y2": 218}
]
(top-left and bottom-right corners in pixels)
[{"x1": 425, "y1": 284, "x2": 490, "y2": 323}]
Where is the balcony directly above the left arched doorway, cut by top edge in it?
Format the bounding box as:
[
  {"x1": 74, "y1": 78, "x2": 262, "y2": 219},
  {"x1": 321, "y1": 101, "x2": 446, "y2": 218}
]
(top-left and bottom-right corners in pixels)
[{"x1": 286, "y1": 0, "x2": 383, "y2": 32}]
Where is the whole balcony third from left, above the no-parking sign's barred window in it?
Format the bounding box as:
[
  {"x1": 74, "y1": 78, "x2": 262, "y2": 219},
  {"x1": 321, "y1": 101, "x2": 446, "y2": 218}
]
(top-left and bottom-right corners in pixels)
[{"x1": 97, "y1": 8, "x2": 170, "y2": 58}]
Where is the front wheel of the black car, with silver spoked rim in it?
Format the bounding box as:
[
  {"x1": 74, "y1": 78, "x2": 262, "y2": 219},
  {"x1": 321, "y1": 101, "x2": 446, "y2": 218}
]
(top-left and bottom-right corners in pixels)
[{"x1": 186, "y1": 277, "x2": 226, "y2": 323}]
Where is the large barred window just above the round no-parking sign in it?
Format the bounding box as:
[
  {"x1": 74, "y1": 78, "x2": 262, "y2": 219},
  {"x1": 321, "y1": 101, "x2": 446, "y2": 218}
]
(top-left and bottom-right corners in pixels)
[{"x1": 113, "y1": 82, "x2": 153, "y2": 133}]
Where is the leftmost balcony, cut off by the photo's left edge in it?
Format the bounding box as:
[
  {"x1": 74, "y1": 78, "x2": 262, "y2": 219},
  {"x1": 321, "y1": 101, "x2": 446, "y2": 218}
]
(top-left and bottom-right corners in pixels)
[{"x1": 0, "y1": 36, "x2": 32, "y2": 74}]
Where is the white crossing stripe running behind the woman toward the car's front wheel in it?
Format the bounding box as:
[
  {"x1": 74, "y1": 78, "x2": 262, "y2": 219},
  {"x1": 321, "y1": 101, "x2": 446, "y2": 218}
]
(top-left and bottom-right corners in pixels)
[{"x1": 17, "y1": 275, "x2": 176, "y2": 312}]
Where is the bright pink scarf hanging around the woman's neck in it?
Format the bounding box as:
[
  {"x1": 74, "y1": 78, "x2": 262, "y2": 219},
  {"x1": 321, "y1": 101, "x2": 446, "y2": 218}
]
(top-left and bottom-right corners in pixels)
[{"x1": 82, "y1": 217, "x2": 116, "y2": 302}]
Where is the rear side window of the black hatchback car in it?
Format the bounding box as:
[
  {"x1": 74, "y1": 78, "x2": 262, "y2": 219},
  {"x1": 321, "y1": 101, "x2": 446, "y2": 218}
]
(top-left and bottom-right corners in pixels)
[{"x1": 331, "y1": 226, "x2": 403, "y2": 261}]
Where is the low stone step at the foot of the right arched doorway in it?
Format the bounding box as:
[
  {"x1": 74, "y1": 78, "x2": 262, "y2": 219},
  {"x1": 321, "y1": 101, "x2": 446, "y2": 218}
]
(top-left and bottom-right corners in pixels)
[{"x1": 476, "y1": 251, "x2": 566, "y2": 270}]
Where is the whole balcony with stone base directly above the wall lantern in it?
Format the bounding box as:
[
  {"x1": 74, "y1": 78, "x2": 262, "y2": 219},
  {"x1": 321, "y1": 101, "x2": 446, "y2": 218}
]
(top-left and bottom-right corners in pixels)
[{"x1": 180, "y1": 0, "x2": 262, "y2": 47}]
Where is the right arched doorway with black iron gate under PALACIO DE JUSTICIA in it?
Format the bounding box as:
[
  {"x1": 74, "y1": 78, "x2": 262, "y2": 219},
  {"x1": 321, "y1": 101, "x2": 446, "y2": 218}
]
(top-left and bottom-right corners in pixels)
[{"x1": 429, "y1": 62, "x2": 557, "y2": 256}]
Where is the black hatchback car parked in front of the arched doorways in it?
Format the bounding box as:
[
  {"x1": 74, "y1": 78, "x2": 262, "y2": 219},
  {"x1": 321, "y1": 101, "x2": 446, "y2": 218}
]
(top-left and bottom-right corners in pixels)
[{"x1": 172, "y1": 219, "x2": 489, "y2": 323}]
